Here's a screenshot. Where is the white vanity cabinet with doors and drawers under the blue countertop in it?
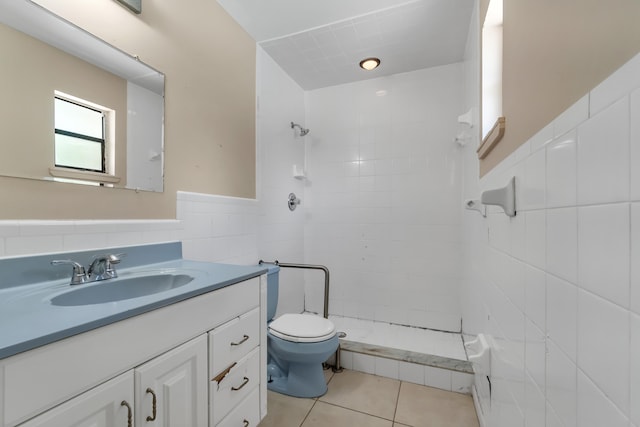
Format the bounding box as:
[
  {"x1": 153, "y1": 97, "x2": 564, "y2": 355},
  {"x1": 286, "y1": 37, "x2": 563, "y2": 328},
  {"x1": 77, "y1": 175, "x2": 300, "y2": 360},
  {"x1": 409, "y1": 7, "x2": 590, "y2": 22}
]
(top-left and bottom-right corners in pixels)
[{"x1": 0, "y1": 276, "x2": 266, "y2": 427}]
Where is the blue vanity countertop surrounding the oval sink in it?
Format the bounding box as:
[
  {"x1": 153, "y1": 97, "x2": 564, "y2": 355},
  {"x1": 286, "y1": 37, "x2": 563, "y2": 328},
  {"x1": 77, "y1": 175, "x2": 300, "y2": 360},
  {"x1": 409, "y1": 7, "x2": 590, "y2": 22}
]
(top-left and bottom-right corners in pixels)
[{"x1": 0, "y1": 244, "x2": 267, "y2": 359}]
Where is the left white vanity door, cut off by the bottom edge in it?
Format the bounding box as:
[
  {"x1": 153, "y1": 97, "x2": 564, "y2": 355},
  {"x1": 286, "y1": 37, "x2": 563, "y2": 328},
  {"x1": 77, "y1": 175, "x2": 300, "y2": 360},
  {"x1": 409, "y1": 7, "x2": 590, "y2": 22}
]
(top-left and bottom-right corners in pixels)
[{"x1": 21, "y1": 371, "x2": 134, "y2": 427}]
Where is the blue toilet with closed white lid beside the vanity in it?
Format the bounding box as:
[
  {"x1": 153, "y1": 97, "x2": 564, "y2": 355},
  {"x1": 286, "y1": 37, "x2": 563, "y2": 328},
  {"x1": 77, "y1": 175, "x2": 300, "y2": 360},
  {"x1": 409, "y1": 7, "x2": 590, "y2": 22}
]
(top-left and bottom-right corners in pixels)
[{"x1": 267, "y1": 265, "x2": 338, "y2": 397}]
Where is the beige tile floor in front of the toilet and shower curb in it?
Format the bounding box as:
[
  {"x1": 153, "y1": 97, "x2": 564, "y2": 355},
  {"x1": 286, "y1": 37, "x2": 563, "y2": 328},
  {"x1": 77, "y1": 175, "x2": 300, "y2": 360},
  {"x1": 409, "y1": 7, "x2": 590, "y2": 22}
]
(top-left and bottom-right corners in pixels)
[{"x1": 259, "y1": 370, "x2": 479, "y2": 427}]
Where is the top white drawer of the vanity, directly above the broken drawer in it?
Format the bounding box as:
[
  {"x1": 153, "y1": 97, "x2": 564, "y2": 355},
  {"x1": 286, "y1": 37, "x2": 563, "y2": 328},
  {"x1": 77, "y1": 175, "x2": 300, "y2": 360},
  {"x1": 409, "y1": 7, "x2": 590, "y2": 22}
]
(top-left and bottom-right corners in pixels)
[{"x1": 209, "y1": 307, "x2": 260, "y2": 375}]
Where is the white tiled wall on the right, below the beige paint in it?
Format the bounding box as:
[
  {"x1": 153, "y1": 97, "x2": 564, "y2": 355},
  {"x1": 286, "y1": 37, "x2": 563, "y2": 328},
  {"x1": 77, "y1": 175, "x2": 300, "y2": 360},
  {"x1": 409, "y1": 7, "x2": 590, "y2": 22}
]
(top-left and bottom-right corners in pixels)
[{"x1": 463, "y1": 55, "x2": 640, "y2": 427}]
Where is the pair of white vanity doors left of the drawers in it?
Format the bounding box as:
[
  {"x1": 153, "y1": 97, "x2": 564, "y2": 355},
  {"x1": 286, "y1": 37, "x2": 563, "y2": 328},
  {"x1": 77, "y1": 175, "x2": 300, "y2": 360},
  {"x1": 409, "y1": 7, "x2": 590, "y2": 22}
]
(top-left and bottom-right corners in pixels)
[{"x1": 21, "y1": 334, "x2": 207, "y2": 427}]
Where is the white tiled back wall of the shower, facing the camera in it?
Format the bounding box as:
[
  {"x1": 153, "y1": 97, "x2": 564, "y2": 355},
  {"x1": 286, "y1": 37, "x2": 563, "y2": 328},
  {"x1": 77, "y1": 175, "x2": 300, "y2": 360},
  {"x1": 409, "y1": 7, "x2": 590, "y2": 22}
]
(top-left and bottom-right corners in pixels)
[{"x1": 304, "y1": 64, "x2": 464, "y2": 331}]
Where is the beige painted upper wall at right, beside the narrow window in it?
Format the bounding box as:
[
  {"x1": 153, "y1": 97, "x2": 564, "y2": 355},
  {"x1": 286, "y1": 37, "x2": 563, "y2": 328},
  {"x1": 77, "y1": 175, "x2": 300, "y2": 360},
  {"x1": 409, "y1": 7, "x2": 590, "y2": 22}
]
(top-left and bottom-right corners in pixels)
[{"x1": 480, "y1": 0, "x2": 640, "y2": 175}]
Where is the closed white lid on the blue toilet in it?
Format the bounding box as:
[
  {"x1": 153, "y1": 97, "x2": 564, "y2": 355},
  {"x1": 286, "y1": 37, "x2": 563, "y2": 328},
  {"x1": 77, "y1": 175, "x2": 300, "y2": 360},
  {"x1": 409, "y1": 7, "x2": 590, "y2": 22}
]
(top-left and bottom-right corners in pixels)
[{"x1": 269, "y1": 314, "x2": 336, "y2": 342}]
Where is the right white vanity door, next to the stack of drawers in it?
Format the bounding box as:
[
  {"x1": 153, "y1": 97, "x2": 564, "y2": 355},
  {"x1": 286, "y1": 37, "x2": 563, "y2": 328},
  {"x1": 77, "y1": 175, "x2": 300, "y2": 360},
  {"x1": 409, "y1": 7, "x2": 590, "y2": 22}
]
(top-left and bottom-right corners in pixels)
[{"x1": 135, "y1": 335, "x2": 208, "y2": 427}]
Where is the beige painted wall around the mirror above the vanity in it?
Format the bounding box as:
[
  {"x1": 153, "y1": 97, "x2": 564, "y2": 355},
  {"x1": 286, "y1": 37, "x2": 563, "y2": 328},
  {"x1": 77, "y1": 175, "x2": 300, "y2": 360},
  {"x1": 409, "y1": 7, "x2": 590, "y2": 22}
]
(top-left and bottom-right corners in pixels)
[{"x1": 0, "y1": 0, "x2": 255, "y2": 219}]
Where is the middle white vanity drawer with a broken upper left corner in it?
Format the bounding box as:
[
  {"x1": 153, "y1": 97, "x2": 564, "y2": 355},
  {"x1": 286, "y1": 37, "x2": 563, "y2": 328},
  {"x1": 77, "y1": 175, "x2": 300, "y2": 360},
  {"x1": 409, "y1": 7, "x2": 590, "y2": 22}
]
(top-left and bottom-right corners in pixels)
[{"x1": 209, "y1": 347, "x2": 260, "y2": 425}]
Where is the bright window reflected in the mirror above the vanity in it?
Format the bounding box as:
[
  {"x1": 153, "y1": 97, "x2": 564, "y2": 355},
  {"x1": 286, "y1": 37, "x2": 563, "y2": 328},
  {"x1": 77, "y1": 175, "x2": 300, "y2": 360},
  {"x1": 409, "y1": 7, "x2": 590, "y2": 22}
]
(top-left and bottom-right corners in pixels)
[{"x1": 54, "y1": 95, "x2": 107, "y2": 173}]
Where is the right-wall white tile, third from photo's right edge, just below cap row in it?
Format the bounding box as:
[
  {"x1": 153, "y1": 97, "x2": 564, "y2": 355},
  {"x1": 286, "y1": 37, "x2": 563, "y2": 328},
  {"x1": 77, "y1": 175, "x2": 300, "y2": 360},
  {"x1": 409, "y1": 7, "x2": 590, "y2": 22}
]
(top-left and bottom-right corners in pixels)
[{"x1": 546, "y1": 131, "x2": 577, "y2": 207}]
